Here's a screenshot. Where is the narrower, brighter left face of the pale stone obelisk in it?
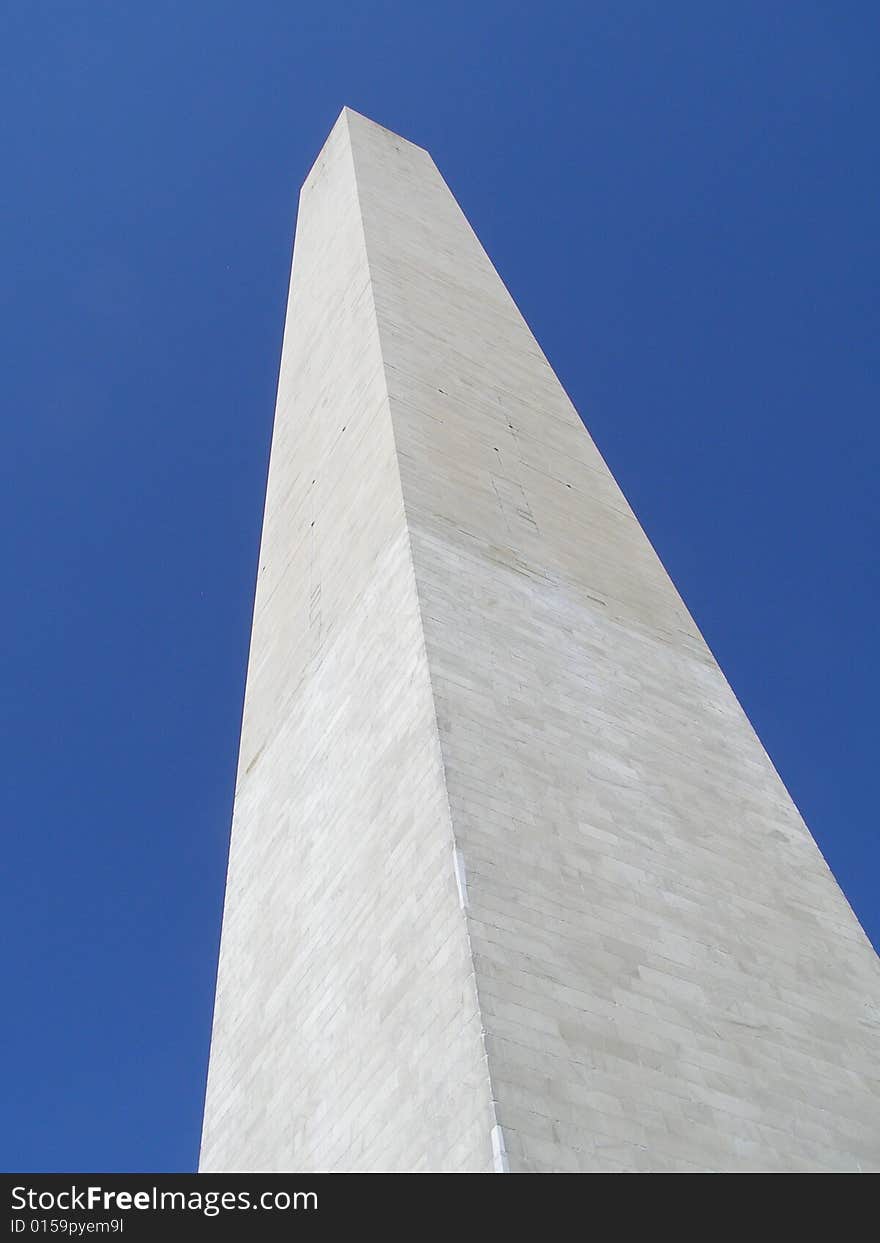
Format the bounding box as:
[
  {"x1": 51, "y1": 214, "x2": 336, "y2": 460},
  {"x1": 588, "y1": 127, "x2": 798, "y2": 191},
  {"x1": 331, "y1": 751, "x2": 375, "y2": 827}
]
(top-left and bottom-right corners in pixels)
[{"x1": 200, "y1": 111, "x2": 493, "y2": 1171}]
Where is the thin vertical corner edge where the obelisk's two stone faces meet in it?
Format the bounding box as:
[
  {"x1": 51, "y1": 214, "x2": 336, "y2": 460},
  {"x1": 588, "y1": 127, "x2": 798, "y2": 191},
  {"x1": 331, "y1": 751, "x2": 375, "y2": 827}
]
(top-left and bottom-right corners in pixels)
[{"x1": 346, "y1": 109, "x2": 508, "y2": 1173}]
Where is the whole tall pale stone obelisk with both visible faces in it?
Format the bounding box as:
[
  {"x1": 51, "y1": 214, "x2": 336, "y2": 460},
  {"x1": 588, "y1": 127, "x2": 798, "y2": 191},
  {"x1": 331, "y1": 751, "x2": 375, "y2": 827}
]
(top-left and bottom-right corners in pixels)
[{"x1": 201, "y1": 111, "x2": 880, "y2": 1171}]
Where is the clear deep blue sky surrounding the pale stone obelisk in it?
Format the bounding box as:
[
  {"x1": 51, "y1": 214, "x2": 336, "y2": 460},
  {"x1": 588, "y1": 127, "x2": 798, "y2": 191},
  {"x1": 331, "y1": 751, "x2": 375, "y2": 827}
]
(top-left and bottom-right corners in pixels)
[{"x1": 0, "y1": 0, "x2": 880, "y2": 1171}]
